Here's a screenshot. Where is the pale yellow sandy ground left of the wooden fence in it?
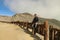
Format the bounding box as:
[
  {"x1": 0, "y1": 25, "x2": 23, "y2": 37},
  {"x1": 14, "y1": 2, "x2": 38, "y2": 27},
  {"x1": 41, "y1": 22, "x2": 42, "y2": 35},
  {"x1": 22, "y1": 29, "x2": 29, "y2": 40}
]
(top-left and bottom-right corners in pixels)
[{"x1": 0, "y1": 22, "x2": 43, "y2": 40}]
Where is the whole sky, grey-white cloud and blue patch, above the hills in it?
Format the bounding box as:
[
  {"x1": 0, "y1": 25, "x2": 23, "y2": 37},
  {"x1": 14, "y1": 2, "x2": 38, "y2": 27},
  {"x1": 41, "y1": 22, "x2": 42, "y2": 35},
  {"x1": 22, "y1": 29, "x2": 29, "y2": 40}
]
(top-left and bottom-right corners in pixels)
[{"x1": 0, "y1": 0, "x2": 60, "y2": 20}]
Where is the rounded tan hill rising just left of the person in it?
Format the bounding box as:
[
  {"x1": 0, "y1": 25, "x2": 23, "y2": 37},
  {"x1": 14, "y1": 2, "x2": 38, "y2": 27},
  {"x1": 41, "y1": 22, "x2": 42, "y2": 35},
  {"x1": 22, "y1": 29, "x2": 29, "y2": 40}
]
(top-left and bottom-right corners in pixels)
[{"x1": 12, "y1": 13, "x2": 33, "y2": 22}]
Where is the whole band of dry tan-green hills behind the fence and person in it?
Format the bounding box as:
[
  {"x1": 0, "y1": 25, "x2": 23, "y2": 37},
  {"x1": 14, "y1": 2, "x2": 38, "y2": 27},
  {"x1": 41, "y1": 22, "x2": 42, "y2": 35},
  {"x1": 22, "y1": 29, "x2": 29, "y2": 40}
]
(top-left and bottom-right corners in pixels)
[{"x1": 0, "y1": 13, "x2": 60, "y2": 28}]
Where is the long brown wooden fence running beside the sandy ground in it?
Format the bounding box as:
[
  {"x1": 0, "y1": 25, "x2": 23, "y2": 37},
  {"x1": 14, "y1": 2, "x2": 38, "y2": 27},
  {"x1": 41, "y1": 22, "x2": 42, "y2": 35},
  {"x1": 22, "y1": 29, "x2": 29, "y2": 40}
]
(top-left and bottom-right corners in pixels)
[{"x1": 12, "y1": 21, "x2": 60, "y2": 40}]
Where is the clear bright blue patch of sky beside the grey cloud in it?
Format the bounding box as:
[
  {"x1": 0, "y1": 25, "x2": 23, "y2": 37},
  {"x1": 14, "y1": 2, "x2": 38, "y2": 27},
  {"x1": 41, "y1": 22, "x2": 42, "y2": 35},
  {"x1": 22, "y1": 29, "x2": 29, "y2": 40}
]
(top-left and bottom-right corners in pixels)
[{"x1": 0, "y1": 0, "x2": 14, "y2": 16}]
